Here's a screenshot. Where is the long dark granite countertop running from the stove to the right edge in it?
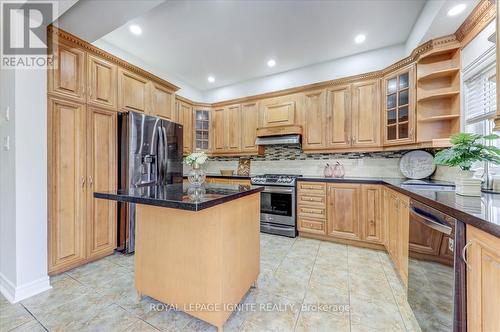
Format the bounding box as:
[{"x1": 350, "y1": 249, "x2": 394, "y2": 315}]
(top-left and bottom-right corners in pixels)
[{"x1": 298, "y1": 176, "x2": 500, "y2": 237}]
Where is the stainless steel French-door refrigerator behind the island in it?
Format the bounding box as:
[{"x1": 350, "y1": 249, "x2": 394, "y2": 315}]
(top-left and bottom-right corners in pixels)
[{"x1": 117, "y1": 112, "x2": 183, "y2": 253}]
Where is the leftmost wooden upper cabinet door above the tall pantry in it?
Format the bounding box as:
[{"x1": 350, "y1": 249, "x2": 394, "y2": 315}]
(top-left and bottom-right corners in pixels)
[{"x1": 48, "y1": 43, "x2": 86, "y2": 102}]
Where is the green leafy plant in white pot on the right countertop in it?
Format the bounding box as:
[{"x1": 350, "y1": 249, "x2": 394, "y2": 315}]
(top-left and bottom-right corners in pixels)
[{"x1": 434, "y1": 133, "x2": 500, "y2": 196}]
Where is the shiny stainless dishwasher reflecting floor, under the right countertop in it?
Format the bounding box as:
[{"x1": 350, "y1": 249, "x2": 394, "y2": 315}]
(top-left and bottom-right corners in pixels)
[{"x1": 408, "y1": 200, "x2": 466, "y2": 332}]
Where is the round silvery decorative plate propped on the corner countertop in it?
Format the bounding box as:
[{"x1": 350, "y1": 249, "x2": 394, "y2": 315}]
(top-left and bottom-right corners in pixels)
[{"x1": 399, "y1": 150, "x2": 436, "y2": 179}]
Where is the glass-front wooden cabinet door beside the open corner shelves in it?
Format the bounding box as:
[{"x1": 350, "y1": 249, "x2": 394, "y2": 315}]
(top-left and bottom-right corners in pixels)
[{"x1": 382, "y1": 65, "x2": 416, "y2": 145}]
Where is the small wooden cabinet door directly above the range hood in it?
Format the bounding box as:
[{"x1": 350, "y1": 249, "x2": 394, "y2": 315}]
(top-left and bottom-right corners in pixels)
[{"x1": 260, "y1": 96, "x2": 296, "y2": 128}]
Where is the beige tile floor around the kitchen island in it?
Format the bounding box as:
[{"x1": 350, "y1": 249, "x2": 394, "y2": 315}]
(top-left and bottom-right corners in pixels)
[{"x1": 0, "y1": 234, "x2": 418, "y2": 332}]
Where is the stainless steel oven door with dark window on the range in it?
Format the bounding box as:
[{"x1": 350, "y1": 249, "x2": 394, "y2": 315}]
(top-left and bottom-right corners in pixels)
[{"x1": 260, "y1": 186, "x2": 295, "y2": 226}]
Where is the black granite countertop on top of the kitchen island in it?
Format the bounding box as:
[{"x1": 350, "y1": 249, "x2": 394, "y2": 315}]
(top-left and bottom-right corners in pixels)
[{"x1": 94, "y1": 183, "x2": 264, "y2": 211}]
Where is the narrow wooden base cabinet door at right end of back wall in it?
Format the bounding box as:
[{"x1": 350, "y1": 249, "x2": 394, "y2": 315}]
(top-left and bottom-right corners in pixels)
[{"x1": 361, "y1": 184, "x2": 385, "y2": 244}]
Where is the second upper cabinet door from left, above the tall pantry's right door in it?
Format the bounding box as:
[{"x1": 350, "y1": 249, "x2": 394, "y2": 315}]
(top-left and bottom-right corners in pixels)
[{"x1": 87, "y1": 54, "x2": 118, "y2": 109}]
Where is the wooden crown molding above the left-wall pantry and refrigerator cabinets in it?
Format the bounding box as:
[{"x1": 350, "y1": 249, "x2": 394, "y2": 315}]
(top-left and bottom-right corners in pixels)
[{"x1": 47, "y1": 25, "x2": 180, "y2": 91}]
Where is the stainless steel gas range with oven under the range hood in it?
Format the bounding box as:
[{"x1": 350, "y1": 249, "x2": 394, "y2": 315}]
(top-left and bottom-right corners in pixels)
[{"x1": 250, "y1": 174, "x2": 300, "y2": 237}]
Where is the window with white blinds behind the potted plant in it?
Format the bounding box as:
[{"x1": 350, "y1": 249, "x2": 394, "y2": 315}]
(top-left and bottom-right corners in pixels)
[{"x1": 464, "y1": 56, "x2": 500, "y2": 173}]
